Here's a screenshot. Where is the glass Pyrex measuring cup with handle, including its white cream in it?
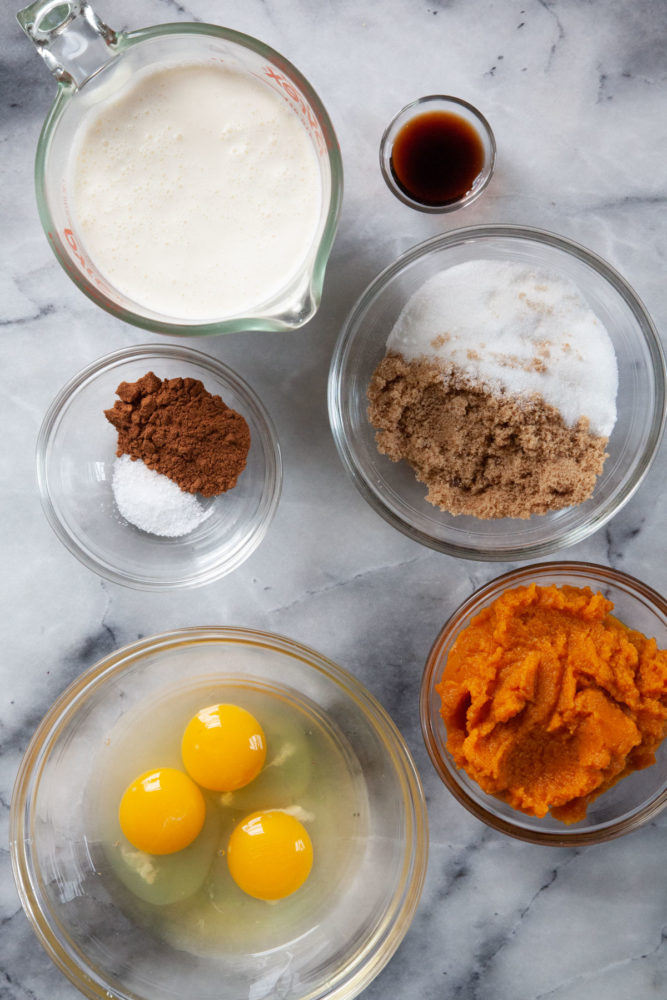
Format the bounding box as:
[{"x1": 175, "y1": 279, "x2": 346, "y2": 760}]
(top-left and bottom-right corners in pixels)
[{"x1": 18, "y1": 0, "x2": 343, "y2": 336}]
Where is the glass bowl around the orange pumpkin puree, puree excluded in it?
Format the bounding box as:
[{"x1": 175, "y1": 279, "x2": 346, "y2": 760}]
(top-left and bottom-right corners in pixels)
[{"x1": 420, "y1": 562, "x2": 667, "y2": 847}]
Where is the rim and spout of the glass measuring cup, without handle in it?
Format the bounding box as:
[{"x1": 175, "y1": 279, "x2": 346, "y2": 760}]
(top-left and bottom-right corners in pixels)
[{"x1": 33, "y1": 21, "x2": 344, "y2": 337}]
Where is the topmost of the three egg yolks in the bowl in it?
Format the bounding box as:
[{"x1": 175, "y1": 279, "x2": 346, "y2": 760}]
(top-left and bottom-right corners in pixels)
[{"x1": 181, "y1": 705, "x2": 266, "y2": 792}]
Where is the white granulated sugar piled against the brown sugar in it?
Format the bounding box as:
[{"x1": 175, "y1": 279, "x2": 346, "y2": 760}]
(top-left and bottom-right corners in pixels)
[{"x1": 387, "y1": 260, "x2": 618, "y2": 437}]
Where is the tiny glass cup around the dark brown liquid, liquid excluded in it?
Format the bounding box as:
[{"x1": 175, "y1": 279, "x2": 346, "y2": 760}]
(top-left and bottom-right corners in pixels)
[{"x1": 380, "y1": 94, "x2": 496, "y2": 214}]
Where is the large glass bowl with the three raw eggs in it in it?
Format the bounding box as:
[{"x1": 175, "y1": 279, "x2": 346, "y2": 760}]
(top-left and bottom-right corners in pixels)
[{"x1": 10, "y1": 628, "x2": 428, "y2": 1000}]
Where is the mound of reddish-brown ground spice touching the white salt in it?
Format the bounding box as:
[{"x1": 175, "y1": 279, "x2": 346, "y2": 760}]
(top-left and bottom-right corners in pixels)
[{"x1": 104, "y1": 372, "x2": 250, "y2": 497}]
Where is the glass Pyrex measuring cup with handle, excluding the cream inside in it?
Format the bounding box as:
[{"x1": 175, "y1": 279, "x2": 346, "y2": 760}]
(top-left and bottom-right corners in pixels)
[{"x1": 17, "y1": 0, "x2": 343, "y2": 336}]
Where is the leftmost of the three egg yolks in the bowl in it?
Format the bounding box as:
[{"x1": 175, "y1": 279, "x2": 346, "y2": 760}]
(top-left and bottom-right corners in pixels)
[{"x1": 118, "y1": 767, "x2": 206, "y2": 854}]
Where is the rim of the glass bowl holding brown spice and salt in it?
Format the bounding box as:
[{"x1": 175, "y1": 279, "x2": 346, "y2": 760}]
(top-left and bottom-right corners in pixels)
[{"x1": 35, "y1": 343, "x2": 283, "y2": 592}]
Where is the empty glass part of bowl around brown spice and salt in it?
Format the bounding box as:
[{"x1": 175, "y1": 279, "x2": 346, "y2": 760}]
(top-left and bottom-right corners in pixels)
[{"x1": 37, "y1": 344, "x2": 282, "y2": 590}]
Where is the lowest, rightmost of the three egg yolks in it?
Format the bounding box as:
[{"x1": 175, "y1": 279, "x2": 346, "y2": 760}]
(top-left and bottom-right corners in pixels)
[{"x1": 227, "y1": 809, "x2": 313, "y2": 900}]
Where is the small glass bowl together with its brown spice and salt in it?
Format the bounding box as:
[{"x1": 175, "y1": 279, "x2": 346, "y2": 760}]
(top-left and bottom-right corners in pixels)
[{"x1": 37, "y1": 345, "x2": 282, "y2": 590}]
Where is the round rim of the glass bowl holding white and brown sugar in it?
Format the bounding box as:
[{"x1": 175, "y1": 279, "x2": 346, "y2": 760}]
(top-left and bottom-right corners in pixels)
[{"x1": 327, "y1": 223, "x2": 667, "y2": 562}]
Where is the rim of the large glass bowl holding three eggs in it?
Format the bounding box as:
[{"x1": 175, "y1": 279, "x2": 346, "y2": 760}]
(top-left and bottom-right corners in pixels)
[{"x1": 9, "y1": 626, "x2": 429, "y2": 1000}]
